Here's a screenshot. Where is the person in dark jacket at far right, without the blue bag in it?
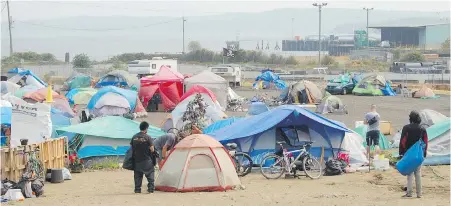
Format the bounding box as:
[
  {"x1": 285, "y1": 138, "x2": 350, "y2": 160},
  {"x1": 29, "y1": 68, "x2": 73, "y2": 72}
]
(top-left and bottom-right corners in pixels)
[{"x1": 399, "y1": 111, "x2": 428, "y2": 198}]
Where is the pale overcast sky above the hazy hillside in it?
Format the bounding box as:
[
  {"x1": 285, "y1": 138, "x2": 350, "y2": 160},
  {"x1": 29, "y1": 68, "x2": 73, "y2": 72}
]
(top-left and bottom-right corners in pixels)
[{"x1": 1, "y1": 0, "x2": 450, "y2": 22}]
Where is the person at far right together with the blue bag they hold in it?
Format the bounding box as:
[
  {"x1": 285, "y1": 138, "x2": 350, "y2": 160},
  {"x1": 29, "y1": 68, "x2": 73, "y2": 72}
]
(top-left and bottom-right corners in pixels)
[{"x1": 396, "y1": 111, "x2": 428, "y2": 198}]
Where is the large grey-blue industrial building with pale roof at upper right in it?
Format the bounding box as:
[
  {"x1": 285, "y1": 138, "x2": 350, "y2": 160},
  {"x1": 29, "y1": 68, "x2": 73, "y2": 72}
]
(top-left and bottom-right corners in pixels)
[{"x1": 369, "y1": 19, "x2": 450, "y2": 50}]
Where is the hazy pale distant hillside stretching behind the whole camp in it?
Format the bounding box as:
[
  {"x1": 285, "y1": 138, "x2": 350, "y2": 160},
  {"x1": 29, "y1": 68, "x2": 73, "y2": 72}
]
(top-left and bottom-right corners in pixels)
[{"x1": 2, "y1": 8, "x2": 449, "y2": 59}]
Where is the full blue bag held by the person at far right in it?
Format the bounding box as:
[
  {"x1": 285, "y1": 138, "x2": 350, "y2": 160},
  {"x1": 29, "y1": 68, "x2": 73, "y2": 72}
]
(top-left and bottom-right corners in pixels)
[{"x1": 396, "y1": 140, "x2": 424, "y2": 176}]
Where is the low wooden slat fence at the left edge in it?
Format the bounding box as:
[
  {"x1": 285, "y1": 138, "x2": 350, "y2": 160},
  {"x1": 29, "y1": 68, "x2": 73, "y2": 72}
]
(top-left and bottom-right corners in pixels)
[{"x1": 0, "y1": 137, "x2": 66, "y2": 182}]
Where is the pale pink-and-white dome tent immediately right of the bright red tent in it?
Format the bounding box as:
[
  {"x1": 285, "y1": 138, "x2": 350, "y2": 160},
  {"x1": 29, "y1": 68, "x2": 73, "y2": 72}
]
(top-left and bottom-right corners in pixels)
[{"x1": 184, "y1": 70, "x2": 229, "y2": 111}]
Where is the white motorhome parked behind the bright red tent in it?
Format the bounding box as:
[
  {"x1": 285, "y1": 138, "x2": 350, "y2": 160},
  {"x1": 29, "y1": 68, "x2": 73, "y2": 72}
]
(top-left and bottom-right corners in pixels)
[{"x1": 127, "y1": 57, "x2": 177, "y2": 78}]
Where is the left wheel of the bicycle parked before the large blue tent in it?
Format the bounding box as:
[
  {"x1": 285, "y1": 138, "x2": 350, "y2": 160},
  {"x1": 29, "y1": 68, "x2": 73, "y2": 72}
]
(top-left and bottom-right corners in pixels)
[{"x1": 260, "y1": 155, "x2": 286, "y2": 179}]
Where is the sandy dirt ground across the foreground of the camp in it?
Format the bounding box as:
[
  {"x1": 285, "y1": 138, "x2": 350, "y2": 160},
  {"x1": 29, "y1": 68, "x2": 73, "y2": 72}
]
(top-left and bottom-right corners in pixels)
[{"x1": 21, "y1": 166, "x2": 450, "y2": 206}]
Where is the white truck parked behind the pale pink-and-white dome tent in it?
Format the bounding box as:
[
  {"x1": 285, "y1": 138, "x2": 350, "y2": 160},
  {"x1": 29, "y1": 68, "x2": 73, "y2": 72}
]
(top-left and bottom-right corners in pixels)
[{"x1": 208, "y1": 64, "x2": 242, "y2": 87}]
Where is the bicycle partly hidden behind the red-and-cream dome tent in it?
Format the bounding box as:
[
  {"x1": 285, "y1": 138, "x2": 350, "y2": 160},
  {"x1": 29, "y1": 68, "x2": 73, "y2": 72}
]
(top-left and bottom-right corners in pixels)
[{"x1": 226, "y1": 143, "x2": 253, "y2": 177}]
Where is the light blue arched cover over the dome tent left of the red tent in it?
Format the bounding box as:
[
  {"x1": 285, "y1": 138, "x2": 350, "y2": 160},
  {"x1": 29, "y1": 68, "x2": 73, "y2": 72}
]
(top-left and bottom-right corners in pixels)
[{"x1": 87, "y1": 86, "x2": 138, "y2": 111}]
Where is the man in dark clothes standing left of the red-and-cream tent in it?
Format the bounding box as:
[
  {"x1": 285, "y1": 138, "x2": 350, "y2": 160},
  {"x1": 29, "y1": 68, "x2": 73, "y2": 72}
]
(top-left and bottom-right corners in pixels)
[{"x1": 130, "y1": 122, "x2": 155, "y2": 193}]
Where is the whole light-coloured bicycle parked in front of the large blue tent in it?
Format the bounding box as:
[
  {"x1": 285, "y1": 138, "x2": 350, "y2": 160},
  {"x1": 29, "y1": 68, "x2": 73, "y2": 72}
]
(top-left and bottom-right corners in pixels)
[{"x1": 260, "y1": 142, "x2": 323, "y2": 179}]
